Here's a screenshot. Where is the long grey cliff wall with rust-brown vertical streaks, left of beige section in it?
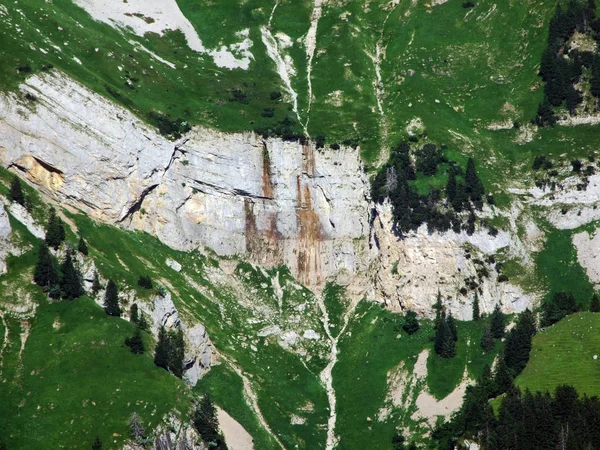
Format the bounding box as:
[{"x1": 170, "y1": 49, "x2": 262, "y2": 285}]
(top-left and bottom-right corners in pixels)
[{"x1": 0, "y1": 70, "x2": 368, "y2": 286}]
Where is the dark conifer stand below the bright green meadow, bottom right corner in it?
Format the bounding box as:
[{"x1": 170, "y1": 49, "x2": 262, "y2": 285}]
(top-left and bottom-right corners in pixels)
[{"x1": 433, "y1": 378, "x2": 600, "y2": 450}]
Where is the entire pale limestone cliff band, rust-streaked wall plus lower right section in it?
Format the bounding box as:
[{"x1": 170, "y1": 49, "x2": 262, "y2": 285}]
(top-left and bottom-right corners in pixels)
[{"x1": 0, "y1": 72, "x2": 531, "y2": 318}]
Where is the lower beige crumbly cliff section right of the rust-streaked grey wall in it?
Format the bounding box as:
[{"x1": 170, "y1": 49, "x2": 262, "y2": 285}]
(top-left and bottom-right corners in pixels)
[{"x1": 371, "y1": 204, "x2": 534, "y2": 320}]
